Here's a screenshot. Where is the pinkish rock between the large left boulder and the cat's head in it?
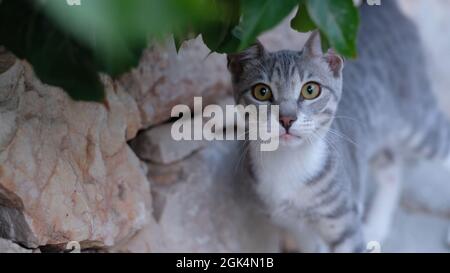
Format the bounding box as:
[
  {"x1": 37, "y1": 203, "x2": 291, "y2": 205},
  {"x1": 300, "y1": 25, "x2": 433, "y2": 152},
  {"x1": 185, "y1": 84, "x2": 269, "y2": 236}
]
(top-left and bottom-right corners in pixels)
[{"x1": 118, "y1": 37, "x2": 231, "y2": 128}]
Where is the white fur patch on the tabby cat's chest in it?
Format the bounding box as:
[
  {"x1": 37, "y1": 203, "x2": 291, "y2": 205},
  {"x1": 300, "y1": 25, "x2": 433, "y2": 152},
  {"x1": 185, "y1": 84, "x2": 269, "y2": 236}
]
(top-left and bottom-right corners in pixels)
[{"x1": 251, "y1": 142, "x2": 326, "y2": 213}]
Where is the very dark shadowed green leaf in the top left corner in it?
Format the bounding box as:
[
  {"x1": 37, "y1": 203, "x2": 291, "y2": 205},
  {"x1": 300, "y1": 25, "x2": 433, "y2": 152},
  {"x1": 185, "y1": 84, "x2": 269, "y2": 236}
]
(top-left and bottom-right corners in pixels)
[{"x1": 0, "y1": 0, "x2": 105, "y2": 101}]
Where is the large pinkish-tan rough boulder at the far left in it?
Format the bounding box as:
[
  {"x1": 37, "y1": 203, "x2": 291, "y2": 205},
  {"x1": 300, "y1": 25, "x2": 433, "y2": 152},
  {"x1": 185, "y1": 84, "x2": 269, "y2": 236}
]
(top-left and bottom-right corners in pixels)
[{"x1": 0, "y1": 55, "x2": 151, "y2": 248}]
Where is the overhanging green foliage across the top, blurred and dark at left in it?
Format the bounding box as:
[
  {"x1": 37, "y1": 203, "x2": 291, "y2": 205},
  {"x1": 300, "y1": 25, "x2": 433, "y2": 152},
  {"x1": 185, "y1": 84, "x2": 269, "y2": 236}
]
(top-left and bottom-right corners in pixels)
[{"x1": 0, "y1": 0, "x2": 359, "y2": 101}]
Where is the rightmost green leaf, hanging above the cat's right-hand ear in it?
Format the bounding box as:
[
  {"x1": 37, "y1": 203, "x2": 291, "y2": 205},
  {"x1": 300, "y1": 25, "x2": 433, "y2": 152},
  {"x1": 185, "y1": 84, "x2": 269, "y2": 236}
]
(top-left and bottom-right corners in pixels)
[{"x1": 306, "y1": 0, "x2": 359, "y2": 58}]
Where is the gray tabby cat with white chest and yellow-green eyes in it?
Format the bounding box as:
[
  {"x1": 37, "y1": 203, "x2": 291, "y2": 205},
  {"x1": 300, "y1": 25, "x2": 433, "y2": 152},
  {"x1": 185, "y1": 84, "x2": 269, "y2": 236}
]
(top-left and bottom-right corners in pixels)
[{"x1": 228, "y1": 1, "x2": 450, "y2": 252}]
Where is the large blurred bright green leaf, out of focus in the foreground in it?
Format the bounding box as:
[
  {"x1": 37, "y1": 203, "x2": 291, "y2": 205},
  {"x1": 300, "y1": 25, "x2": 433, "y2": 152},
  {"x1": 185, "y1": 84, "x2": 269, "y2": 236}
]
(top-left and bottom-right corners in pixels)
[{"x1": 44, "y1": 0, "x2": 222, "y2": 68}]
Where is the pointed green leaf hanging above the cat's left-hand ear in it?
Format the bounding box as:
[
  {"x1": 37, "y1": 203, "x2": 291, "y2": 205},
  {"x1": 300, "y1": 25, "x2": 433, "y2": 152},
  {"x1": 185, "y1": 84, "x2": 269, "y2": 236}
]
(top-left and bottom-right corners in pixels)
[{"x1": 239, "y1": 0, "x2": 298, "y2": 50}]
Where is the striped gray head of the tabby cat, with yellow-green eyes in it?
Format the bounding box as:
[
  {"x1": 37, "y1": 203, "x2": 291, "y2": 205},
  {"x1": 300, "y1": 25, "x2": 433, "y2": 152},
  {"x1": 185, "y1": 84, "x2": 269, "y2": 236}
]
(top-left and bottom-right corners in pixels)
[{"x1": 228, "y1": 32, "x2": 344, "y2": 146}]
